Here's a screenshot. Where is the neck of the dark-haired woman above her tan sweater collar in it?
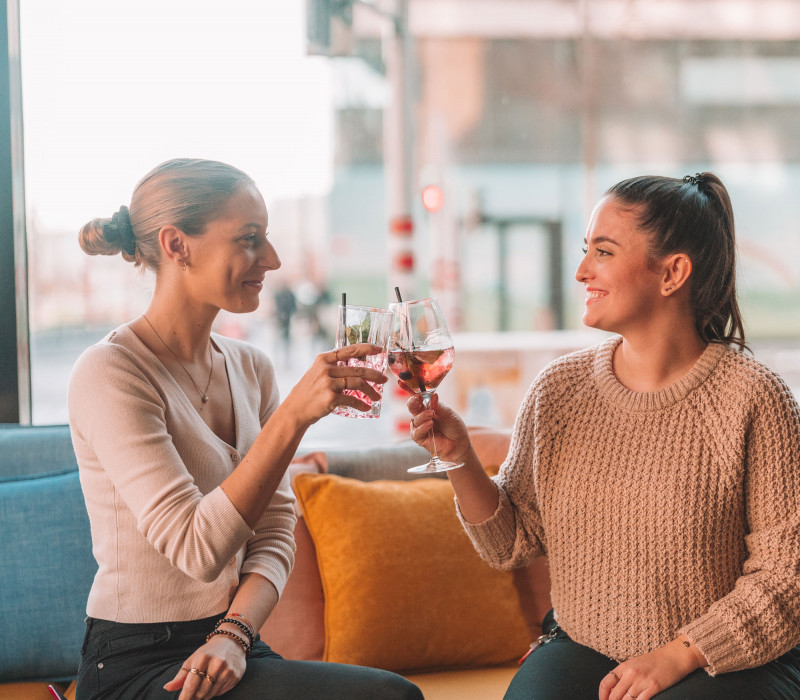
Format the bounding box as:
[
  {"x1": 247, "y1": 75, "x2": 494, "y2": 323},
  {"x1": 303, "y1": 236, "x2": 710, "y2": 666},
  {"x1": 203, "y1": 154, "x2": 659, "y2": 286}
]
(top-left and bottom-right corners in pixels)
[{"x1": 613, "y1": 328, "x2": 707, "y2": 392}]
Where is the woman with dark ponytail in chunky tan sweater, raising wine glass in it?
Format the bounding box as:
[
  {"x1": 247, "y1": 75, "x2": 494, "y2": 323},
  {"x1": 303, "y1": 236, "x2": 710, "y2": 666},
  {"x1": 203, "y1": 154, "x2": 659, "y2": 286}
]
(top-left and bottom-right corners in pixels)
[{"x1": 408, "y1": 173, "x2": 800, "y2": 700}]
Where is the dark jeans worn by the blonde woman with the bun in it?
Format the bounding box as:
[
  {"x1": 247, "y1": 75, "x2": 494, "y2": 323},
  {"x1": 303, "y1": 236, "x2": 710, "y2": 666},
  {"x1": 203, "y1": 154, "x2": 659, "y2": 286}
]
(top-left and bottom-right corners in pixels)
[{"x1": 76, "y1": 615, "x2": 422, "y2": 700}]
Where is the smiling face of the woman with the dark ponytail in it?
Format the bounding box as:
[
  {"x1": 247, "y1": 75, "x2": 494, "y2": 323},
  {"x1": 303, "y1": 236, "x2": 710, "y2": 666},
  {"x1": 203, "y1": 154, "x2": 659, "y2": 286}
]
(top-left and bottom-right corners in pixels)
[{"x1": 575, "y1": 197, "x2": 663, "y2": 336}]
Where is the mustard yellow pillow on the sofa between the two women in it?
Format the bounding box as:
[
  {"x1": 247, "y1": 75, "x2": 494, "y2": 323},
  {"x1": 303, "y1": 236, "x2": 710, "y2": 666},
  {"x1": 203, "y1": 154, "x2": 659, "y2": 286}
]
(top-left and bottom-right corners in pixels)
[{"x1": 294, "y1": 474, "x2": 528, "y2": 671}]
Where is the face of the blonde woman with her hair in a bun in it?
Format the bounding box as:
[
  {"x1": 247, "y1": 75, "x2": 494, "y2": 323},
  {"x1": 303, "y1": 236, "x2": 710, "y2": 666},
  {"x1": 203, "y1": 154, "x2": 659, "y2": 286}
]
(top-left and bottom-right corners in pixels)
[{"x1": 187, "y1": 185, "x2": 281, "y2": 313}]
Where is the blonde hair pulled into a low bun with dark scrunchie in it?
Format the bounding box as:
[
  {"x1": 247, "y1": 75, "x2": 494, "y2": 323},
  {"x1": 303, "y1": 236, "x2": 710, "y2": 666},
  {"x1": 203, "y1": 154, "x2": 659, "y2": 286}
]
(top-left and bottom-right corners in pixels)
[{"x1": 78, "y1": 158, "x2": 253, "y2": 271}]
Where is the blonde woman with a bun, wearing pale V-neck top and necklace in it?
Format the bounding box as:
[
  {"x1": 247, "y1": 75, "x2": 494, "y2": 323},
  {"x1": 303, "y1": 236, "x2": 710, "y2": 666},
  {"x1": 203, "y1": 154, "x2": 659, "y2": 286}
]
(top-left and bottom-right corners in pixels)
[{"x1": 69, "y1": 159, "x2": 422, "y2": 700}]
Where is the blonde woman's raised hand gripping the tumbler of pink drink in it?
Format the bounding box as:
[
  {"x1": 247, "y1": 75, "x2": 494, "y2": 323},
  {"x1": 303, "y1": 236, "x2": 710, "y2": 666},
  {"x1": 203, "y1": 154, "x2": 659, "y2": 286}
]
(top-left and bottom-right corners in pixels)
[{"x1": 284, "y1": 343, "x2": 387, "y2": 426}]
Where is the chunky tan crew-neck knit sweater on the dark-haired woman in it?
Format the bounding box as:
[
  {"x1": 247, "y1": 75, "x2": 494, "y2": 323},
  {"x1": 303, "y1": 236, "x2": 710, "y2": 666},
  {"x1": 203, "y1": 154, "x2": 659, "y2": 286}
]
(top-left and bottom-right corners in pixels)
[{"x1": 459, "y1": 337, "x2": 800, "y2": 675}]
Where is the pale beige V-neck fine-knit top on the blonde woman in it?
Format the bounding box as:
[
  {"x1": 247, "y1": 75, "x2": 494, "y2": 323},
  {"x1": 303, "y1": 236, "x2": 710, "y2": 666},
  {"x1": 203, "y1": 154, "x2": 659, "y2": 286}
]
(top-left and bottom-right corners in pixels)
[{"x1": 69, "y1": 326, "x2": 295, "y2": 623}]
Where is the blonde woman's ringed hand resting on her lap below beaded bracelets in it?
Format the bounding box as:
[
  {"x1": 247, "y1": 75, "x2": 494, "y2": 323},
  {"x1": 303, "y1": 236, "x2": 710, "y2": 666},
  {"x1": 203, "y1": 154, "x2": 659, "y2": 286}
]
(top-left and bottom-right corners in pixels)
[{"x1": 164, "y1": 634, "x2": 247, "y2": 700}]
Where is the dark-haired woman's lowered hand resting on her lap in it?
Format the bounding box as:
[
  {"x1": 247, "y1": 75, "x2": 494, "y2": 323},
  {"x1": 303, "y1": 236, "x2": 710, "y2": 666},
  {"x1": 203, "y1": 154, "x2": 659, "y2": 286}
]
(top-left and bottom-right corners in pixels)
[{"x1": 599, "y1": 635, "x2": 706, "y2": 700}]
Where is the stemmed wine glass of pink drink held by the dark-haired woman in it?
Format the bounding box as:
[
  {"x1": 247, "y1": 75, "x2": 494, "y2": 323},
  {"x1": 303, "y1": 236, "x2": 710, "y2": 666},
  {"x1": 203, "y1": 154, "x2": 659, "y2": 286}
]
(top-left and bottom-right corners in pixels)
[{"x1": 389, "y1": 299, "x2": 464, "y2": 474}]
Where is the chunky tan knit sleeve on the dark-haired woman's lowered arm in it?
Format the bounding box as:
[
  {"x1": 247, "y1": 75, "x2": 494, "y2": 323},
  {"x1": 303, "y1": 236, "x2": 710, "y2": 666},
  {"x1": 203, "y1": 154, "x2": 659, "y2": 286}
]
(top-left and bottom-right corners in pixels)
[{"x1": 681, "y1": 368, "x2": 800, "y2": 675}]
